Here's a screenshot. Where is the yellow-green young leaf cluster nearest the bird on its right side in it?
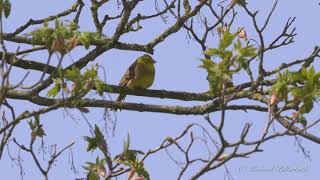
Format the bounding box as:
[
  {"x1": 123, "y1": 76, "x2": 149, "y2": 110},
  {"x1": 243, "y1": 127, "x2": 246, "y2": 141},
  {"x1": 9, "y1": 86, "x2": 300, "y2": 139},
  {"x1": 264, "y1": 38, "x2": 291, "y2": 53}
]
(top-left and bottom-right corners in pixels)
[{"x1": 200, "y1": 28, "x2": 256, "y2": 93}]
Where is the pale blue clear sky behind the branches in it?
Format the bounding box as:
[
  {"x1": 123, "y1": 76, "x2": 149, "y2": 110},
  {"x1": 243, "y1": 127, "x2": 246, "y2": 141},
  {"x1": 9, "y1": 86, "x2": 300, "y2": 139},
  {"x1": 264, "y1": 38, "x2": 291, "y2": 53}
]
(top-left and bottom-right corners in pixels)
[{"x1": 0, "y1": 0, "x2": 320, "y2": 180}]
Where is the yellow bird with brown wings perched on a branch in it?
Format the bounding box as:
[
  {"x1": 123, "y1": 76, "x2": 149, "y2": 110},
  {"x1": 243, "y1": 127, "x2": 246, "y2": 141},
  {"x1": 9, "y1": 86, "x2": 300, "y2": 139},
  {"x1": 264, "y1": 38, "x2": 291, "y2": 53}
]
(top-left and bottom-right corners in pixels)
[{"x1": 117, "y1": 54, "x2": 156, "y2": 101}]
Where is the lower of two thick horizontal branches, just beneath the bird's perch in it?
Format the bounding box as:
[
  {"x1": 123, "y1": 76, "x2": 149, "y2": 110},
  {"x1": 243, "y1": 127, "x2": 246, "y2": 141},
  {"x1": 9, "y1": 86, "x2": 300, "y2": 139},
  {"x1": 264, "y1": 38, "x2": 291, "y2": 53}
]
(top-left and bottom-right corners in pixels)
[{"x1": 7, "y1": 90, "x2": 268, "y2": 115}]
